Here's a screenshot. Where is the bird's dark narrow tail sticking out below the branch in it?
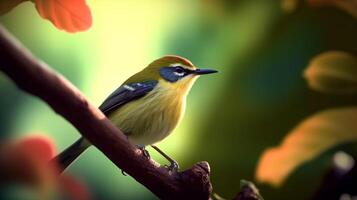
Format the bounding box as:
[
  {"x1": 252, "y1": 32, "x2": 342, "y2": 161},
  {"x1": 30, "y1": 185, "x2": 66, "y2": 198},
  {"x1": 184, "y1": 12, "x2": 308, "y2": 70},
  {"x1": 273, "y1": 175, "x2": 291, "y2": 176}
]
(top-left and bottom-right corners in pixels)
[{"x1": 50, "y1": 137, "x2": 91, "y2": 173}]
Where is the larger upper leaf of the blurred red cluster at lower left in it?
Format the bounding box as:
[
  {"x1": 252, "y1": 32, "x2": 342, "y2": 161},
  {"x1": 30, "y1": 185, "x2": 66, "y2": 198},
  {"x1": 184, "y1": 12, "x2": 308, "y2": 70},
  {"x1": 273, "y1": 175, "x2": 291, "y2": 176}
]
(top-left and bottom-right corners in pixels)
[{"x1": 0, "y1": 136, "x2": 56, "y2": 194}]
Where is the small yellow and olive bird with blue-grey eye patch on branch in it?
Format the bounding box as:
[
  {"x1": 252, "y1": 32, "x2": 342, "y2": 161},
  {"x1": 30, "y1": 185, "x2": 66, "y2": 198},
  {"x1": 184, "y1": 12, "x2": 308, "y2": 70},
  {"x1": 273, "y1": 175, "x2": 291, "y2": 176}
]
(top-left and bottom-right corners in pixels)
[{"x1": 52, "y1": 55, "x2": 218, "y2": 172}]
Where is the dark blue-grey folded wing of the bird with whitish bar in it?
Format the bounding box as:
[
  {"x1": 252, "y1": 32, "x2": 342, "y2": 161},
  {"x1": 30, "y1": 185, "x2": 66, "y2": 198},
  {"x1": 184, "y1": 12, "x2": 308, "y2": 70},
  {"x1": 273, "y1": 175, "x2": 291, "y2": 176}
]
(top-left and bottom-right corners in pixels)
[{"x1": 99, "y1": 80, "x2": 158, "y2": 116}]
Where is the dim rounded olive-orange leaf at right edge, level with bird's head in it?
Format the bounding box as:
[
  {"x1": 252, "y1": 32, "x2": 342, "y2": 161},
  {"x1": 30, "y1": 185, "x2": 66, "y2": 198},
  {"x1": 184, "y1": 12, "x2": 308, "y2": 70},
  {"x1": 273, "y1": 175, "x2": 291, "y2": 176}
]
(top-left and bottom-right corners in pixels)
[{"x1": 304, "y1": 51, "x2": 357, "y2": 94}]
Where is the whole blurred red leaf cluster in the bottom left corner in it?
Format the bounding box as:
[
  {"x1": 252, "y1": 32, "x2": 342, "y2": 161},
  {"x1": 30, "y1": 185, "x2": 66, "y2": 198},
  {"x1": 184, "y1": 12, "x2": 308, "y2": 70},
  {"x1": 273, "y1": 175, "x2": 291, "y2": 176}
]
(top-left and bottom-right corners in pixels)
[{"x1": 0, "y1": 136, "x2": 91, "y2": 200}]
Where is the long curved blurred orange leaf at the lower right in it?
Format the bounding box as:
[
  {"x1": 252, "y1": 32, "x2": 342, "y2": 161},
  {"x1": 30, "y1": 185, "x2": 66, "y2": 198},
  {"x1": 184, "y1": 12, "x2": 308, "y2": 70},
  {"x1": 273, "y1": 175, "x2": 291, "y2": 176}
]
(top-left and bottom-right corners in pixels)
[{"x1": 256, "y1": 107, "x2": 357, "y2": 186}]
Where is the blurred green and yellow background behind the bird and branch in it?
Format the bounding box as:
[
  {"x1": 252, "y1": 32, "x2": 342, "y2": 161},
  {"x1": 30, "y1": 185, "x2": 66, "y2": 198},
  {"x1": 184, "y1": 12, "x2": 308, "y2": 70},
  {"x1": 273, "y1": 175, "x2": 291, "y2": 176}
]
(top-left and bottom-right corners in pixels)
[{"x1": 0, "y1": 0, "x2": 357, "y2": 200}]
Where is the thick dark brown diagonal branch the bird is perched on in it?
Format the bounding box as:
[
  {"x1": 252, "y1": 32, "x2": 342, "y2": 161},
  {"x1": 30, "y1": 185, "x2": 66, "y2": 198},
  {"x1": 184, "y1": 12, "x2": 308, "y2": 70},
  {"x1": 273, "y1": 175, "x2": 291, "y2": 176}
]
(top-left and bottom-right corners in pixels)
[{"x1": 0, "y1": 25, "x2": 262, "y2": 199}]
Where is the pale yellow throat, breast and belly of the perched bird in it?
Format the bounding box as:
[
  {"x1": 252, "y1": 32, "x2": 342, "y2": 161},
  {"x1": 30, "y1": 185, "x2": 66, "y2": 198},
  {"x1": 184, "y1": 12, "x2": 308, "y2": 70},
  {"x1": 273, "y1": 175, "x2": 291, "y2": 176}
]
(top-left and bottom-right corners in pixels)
[{"x1": 109, "y1": 77, "x2": 195, "y2": 145}]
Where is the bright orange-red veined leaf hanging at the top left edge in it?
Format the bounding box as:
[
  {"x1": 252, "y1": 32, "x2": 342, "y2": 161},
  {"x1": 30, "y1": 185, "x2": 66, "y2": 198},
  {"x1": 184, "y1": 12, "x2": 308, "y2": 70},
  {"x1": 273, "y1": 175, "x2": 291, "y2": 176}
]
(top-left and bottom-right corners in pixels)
[{"x1": 32, "y1": 0, "x2": 92, "y2": 33}]
